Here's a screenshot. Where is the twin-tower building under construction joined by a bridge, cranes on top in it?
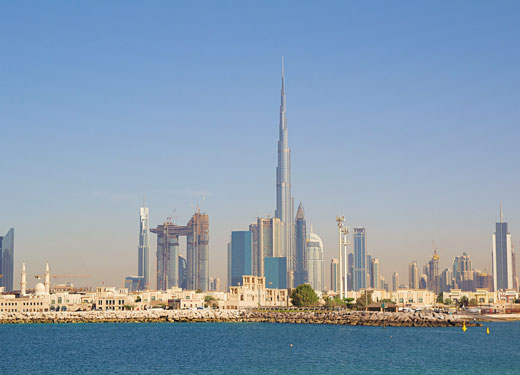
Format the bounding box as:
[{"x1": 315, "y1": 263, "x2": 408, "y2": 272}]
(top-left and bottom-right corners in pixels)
[{"x1": 150, "y1": 212, "x2": 209, "y2": 291}]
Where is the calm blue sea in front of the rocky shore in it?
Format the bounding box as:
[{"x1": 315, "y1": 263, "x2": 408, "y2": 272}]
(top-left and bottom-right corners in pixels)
[{"x1": 0, "y1": 323, "x2": 520, "y2": 374}]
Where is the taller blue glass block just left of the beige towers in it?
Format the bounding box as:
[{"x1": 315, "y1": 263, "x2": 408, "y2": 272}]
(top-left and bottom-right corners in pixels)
[{"x1": 228, "y1": 231, "x2": 252, "y2": 286}]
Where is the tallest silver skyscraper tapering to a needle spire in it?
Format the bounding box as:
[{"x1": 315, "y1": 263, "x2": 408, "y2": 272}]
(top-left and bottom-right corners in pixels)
[{"x1": 275, "y1": 57, "x2": 295, "y2": 287}]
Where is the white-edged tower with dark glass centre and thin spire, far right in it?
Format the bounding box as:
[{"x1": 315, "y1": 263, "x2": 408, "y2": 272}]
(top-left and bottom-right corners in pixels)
[{"x1": 493, "y1": 205, "x2": 513, "y2": 291}]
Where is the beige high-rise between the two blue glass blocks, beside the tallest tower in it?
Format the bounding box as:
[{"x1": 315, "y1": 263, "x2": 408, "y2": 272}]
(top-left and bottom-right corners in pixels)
[{"x1": 255, "y1": 217, "x2": 283, "y2": 276}]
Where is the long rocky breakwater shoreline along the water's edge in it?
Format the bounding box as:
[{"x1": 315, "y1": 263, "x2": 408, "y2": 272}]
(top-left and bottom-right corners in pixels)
[{"x1": 0, "y1": 309, "x2": 488, "y2": 327}]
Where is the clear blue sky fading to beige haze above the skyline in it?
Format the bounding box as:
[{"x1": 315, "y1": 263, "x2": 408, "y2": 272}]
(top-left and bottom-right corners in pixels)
[{"x1": 0, "y1": 1, "x2": 520, "y2": 286}]
